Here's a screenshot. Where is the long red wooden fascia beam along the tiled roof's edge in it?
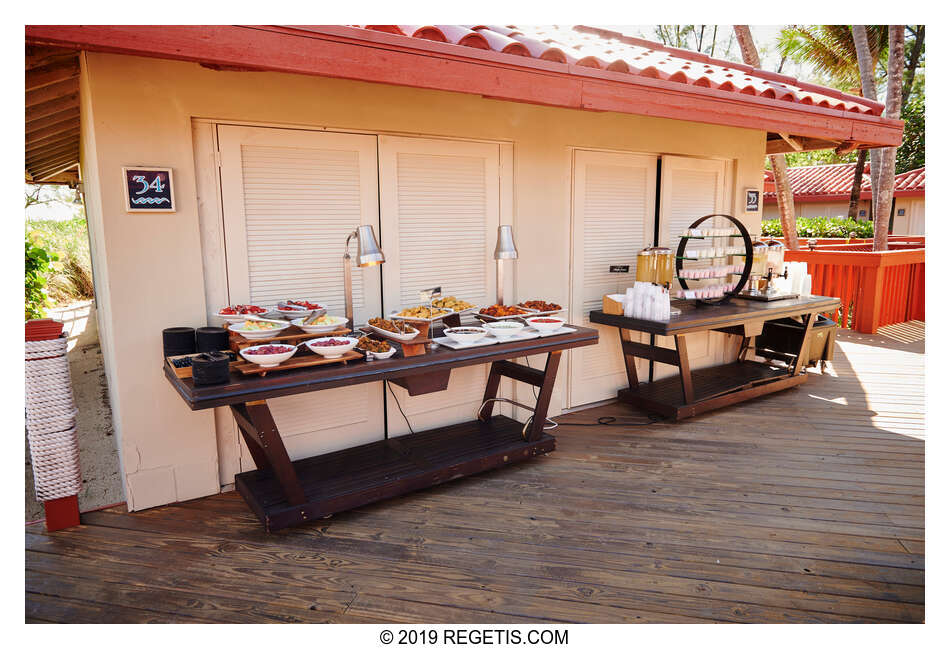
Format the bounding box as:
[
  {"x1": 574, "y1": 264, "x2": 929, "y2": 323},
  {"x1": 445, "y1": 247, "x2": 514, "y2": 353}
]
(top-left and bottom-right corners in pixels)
[{"x1": 26, "y1": 25, "x2": 903, "y2": 146}]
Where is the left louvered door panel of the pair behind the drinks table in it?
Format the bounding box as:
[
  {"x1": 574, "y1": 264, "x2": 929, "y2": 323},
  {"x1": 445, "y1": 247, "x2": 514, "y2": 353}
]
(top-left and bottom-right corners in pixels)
[{"x1": 568, "y1": 151, "x2": 657, "y2": 408}]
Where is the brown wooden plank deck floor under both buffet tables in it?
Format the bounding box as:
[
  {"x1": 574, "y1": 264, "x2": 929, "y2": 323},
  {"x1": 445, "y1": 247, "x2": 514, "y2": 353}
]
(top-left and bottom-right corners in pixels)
[{"x1": 26, "y1": 324, "x2": 924, "y2": 623}]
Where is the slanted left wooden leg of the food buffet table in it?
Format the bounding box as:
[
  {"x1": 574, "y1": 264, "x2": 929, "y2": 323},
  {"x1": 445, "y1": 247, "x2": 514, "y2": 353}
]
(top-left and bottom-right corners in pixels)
[{"x1": 231, "y1": 401, "x2": 307, "y2": 505}]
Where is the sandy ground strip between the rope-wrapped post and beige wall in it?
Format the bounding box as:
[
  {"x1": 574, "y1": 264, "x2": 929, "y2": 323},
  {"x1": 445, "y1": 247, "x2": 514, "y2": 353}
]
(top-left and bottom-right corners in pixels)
[{"x1": 26, "y1": 300, "x2": 125, "y2": 521}]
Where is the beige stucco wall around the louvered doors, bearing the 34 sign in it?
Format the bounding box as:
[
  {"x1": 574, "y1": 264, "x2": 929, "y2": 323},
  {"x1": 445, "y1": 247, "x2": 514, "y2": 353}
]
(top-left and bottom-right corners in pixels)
[{"x1": 82, "y1": 53, "x2": 765, "y2": 509}]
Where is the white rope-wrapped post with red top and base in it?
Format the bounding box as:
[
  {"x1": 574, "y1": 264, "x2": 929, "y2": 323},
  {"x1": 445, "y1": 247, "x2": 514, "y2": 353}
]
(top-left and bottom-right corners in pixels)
[{"x1": 25, "y1": 321, "x2": 82, "y2": 531}]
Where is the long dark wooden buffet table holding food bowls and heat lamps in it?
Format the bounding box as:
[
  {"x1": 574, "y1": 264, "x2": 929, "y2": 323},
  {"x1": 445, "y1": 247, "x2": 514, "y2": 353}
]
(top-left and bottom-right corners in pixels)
[{"x1": 163, "y1": 327, "x2": 598, "y2": 531}]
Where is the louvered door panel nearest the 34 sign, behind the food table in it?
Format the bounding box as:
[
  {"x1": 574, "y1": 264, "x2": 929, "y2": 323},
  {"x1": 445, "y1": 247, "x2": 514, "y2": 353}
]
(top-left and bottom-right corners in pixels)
[{"x1": 218, "y1": 126, "x2": 384, "y2": 460}]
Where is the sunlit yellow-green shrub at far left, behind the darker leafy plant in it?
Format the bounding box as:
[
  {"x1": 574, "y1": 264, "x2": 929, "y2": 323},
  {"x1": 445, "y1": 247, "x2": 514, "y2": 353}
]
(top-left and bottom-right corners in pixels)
[{"x1": 26, "y1": 217, "x2": 94, "y2": 305}]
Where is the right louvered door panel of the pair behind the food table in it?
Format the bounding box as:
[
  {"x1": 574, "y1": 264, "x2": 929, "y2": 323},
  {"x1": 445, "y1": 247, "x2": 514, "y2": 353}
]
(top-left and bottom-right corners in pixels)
[{"x1": 379, "y1": 136, "x2": 500, "y2": 435}]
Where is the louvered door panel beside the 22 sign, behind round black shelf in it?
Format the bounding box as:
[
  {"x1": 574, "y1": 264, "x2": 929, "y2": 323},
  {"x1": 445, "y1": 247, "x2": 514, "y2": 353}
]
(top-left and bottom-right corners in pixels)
[{"x1": 653, "y1": 156, "x2": 731, "y2": 379}]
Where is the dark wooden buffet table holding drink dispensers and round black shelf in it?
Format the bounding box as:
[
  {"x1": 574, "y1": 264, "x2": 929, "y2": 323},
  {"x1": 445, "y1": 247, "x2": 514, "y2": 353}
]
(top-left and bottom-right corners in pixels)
[{"x1": 590, "y1": 296, "x2": 841, "y2": 419}]
